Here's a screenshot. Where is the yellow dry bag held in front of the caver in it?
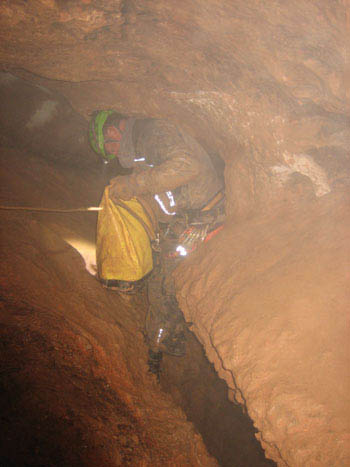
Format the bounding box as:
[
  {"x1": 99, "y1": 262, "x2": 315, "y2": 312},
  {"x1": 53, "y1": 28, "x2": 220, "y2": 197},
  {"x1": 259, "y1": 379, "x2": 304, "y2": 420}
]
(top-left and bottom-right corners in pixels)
[{"x1": 96, "y1": 187, "x2": 155, "y2": 281}]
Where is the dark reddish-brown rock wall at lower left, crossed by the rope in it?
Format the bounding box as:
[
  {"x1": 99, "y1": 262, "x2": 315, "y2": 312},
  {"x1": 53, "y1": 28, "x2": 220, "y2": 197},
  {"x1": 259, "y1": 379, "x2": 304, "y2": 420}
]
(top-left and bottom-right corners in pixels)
[{"x1": 0, "y1": 148, "x2": 217, "y2": 466}]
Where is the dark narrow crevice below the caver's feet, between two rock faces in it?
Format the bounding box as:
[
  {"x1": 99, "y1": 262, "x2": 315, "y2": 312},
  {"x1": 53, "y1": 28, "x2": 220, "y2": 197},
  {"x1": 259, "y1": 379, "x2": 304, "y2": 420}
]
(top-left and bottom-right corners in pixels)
[{"x1": 160, "y1": 330, "x2": 276, "y2": 467}]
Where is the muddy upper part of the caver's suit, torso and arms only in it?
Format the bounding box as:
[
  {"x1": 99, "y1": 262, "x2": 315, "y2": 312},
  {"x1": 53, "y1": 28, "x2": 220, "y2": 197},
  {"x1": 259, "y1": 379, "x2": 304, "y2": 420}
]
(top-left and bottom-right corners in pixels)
[{"x1": 110, "y1": 119, "x2": 223, "y2": 212}]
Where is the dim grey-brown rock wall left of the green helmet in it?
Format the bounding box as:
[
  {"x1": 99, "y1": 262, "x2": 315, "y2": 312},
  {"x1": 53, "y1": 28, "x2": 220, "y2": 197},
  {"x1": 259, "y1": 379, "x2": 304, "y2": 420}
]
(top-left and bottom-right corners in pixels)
[{"x1": 0, "y1": 72, "x2": 98, "y2": 167}]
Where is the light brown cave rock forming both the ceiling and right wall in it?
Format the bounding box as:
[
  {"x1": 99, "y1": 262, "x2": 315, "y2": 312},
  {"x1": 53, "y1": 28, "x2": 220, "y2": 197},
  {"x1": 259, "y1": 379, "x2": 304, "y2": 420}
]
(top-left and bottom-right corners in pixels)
[{"x1": 0, "y1": 0, "x2": 350, "y2": 465}]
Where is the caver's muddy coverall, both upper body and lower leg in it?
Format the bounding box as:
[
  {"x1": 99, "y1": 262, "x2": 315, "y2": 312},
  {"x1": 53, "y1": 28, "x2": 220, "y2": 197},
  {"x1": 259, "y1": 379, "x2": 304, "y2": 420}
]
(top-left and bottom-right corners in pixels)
[{"x1": 110, "y1": 119, "x2": 223, "y2": 356}]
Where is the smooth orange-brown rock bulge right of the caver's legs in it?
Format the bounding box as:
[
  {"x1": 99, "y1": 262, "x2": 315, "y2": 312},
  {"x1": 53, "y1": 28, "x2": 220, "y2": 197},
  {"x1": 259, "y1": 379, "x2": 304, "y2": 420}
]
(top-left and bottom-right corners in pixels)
[{"x1": 177, "y1": 188, "x2": 350, "y2": 466}]
